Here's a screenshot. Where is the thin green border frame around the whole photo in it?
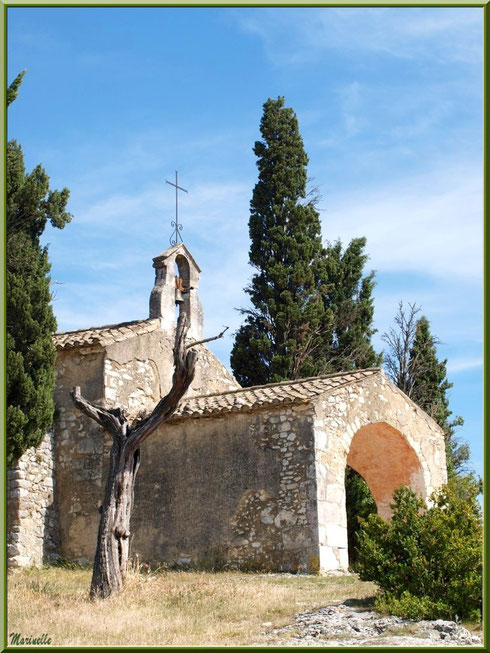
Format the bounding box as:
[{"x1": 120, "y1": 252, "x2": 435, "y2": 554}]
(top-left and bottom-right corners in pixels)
[{"x1": 0, "y1": 0, "x2": 490, "y2": 651}]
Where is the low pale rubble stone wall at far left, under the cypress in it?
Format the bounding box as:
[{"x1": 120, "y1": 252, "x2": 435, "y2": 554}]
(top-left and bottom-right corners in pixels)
[{"x1": 7, "y1": 433, "x2": 59, "y2": 567}]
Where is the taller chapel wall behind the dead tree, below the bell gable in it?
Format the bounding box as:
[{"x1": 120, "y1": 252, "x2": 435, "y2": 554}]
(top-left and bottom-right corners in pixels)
[{"x1": 50, "y1": 330, "x2": 238, "y2": 563}]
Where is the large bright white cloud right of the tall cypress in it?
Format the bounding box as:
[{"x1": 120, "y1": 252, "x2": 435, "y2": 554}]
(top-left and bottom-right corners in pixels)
[{"x1": 323, "y1": 165, "x2": 483, "y2": 282}]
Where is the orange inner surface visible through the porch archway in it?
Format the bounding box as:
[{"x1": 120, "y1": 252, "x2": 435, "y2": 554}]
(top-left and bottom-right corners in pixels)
[{"x1": 346, "y1": 422, "x2": 427, "y2": 519}]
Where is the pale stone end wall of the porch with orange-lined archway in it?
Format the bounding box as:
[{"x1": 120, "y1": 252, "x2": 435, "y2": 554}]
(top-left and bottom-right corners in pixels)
[{"x1": 314, "y1": 371, "x2": 446, "y2": 571}]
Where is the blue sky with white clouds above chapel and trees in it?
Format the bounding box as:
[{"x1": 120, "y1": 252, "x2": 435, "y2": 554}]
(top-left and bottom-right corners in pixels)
[{"x1": 8, "y1": 7, "x2": 483, "y2": 473}]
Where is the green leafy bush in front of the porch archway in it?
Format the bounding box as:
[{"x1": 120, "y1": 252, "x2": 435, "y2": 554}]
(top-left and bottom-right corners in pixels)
[{"x1": 356, "y1": 482, "x2": 483, "y2": 621}]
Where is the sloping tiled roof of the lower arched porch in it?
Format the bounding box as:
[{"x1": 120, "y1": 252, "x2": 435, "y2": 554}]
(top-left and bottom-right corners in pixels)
[{"x1": 172, "y1": 367, "x2": 381, "y2": 419}]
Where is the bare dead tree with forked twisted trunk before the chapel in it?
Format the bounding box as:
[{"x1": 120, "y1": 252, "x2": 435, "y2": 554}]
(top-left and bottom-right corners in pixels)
[{"x1": 71, "y1": 312, "x2": 199, "y2": 599}]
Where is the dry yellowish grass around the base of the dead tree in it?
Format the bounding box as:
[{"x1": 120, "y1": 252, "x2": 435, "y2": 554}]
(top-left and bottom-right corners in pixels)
[{"x1": 8, "y1": 567, "x2": 376, "y2": 646}]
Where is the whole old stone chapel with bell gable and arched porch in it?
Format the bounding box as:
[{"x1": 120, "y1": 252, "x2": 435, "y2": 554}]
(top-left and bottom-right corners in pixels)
[{"x1": 8, "y1": 243, "x2": 446, "y2": 573}]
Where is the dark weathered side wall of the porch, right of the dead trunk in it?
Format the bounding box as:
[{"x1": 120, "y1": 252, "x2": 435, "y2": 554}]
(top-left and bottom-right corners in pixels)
[{"x1": 131, "y1": 405, "x2": 319, "y2": 571}]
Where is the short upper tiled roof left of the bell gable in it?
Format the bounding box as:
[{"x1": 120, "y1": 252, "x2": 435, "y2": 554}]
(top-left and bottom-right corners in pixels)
[{"x1": 54, "y1": 318, "x2": 160, "y2": 349}]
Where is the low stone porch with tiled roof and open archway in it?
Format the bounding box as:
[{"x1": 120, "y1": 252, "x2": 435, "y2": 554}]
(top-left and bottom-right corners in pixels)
[{"x1": 125, "y1": 369, "x2": 446, "y2": 572}]
